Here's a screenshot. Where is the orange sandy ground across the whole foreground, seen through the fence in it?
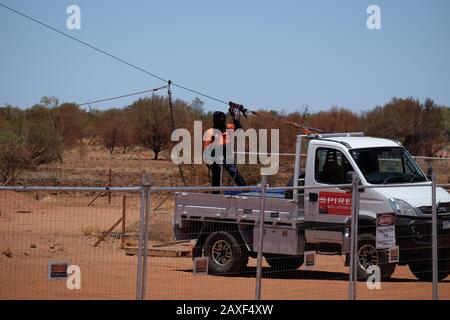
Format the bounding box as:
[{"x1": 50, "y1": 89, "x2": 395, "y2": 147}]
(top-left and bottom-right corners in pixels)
[{"x1": 0, "y1": 192, "x2": 450, "y2": 299}]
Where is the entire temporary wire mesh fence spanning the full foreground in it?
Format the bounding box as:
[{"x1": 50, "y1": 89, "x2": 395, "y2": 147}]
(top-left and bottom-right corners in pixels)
[{"x1": 0, "y1": 176, "x2": 450, "y2": 300}]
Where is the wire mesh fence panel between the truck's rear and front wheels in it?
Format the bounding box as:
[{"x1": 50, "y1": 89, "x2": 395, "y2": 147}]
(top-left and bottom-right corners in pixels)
[{"x1": 262, "y1": 187, "x2": 351, "y2": 300}]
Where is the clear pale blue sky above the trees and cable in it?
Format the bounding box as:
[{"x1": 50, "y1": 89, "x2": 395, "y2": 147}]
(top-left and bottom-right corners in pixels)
[{"x1": 0, "y1": 0, "x2": 450, "y2": 111}]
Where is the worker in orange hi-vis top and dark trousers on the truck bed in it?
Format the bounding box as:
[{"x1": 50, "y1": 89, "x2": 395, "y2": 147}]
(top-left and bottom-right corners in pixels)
[{"x1": 203, "y1": 108, "x2": 247, "y2": 189}]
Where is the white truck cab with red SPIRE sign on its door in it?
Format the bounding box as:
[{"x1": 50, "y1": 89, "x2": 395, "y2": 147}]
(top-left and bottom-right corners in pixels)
[{"x1": 298, "y1": 133, "x2": 450, "y2": 280}]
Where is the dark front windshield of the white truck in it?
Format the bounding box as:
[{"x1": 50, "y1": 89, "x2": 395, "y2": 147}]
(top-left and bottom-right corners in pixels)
[{"x1": 350, "y1": 147, "x2": 427, "y2": 184}]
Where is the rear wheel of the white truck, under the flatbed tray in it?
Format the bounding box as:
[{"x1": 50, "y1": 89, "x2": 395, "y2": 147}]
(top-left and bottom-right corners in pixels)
[{"x1": 203, "y1": 231, "x2": 248, "y2": 274}]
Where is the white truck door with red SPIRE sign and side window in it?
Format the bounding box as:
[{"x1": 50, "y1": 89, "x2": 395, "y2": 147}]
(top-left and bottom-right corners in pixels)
[{"x1": 305, "y1": 146, "x2": 353, "y2": 244}]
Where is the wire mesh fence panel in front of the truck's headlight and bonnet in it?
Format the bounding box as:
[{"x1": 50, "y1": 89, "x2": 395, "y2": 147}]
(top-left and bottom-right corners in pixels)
[{"x1": 358, "y1": 184, "x2": 432, "y2": 300}]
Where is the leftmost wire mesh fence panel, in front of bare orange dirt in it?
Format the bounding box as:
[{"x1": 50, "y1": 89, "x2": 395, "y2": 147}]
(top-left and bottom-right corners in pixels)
[{"x1": 0, "y1": 189, "x2": 140, "y2": 299}]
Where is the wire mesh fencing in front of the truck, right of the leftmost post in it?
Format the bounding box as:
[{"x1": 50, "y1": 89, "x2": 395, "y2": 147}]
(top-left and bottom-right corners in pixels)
[{"x1": 141, "y1": 172, "x2": 450, "y2": 300}]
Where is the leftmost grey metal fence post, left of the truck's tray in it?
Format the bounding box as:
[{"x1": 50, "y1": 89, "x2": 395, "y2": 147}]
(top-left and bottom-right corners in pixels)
[{"x1": 136, "y1": 174, "x2": 150, "y2": 300}]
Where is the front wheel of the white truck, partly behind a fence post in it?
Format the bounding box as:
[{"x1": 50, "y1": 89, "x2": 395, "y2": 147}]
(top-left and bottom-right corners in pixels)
[{"x1": 357, "y1": 234, "x2": 396, "y2": 280}]
